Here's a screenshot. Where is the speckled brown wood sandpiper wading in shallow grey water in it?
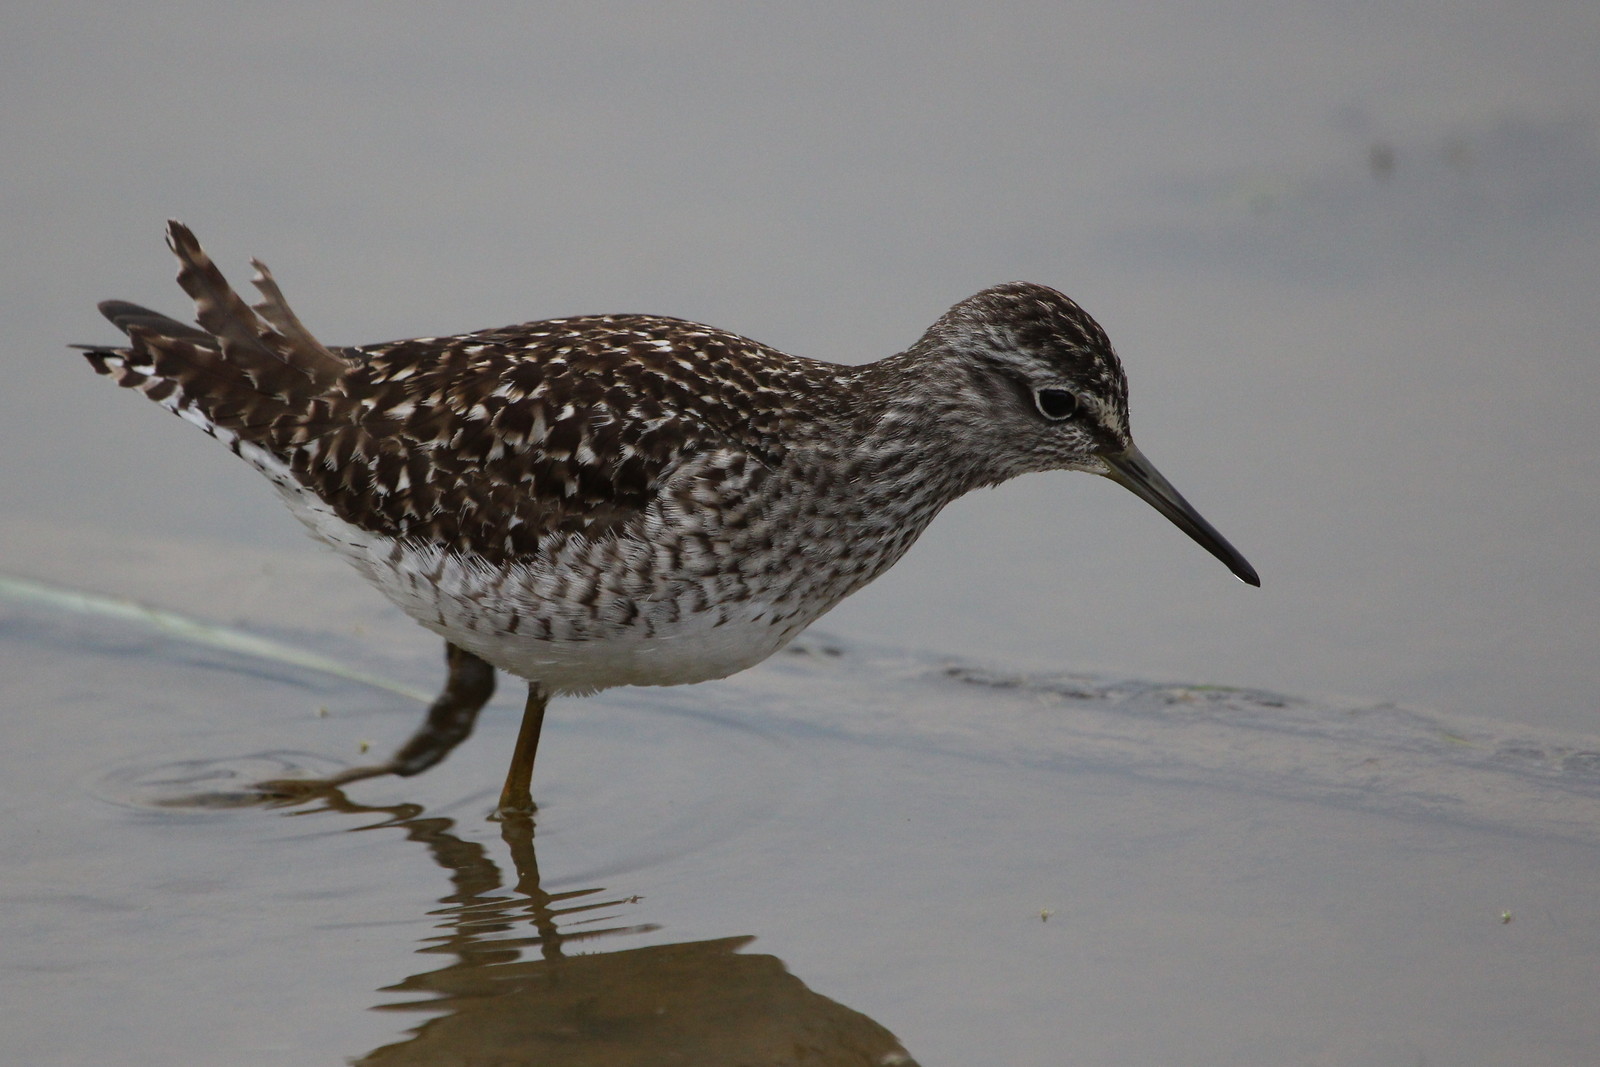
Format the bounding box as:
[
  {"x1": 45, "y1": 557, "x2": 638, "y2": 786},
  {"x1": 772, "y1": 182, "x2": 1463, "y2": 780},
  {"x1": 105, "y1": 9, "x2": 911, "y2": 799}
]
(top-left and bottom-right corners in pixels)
[{"x1": 82, "y1": 222, "x2": 1261, "y2": 813}]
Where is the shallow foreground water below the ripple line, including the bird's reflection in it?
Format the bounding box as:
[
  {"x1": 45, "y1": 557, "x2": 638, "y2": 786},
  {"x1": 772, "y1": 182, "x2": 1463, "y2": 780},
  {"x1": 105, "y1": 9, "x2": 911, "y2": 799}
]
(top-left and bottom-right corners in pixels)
[{"x1": 0, "y1": 542, "x2": 1600, "y2": 1065}]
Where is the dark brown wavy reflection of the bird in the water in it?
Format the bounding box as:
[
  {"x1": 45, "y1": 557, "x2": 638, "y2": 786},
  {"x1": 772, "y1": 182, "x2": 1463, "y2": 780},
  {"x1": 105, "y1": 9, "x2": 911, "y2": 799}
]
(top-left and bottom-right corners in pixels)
[{"x1": 278, "y1": 789, "x2": 914, "y2": 1067}]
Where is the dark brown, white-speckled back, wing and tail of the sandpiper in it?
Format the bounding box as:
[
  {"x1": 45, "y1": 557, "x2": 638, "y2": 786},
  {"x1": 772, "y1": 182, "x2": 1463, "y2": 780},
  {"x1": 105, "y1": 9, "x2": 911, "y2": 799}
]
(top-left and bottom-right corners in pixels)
[{"x1": 90, "y1": 227, "x2": 842, "y2": 563}]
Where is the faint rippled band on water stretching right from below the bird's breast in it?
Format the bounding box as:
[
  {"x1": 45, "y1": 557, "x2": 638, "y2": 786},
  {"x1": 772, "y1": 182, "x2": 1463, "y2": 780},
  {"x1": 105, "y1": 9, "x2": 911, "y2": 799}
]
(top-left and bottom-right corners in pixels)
[{"x1": 742, "y1": 641, "x2": 1600, "y2": 843}]
